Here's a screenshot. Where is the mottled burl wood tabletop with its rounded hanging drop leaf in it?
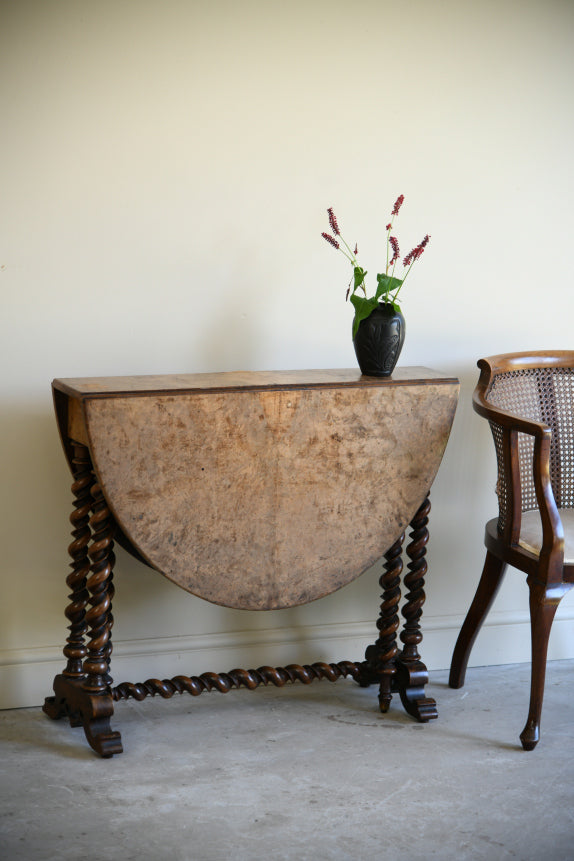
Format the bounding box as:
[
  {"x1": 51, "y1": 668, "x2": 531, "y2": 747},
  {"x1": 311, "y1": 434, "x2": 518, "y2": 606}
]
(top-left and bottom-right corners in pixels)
[{"x1": 54, "y1": 369, "x2": 458, "y2": 610}]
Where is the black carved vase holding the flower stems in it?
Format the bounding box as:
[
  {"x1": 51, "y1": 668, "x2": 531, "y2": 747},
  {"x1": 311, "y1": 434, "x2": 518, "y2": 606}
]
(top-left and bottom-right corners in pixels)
[{"x1": 353, "y1": 304, "x2": 405, "y2": 377}]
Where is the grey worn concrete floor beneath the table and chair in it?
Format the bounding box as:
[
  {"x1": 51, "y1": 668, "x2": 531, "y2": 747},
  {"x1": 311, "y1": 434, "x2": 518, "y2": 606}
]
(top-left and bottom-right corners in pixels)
[{"x1": 0, "y1": 661, "x2": 574, "y2": 861}]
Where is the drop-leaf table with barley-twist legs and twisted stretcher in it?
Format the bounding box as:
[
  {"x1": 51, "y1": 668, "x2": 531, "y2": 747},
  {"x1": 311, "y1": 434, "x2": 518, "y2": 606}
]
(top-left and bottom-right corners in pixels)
[{"x1": 44, "y1": 368, "x2": 459, "y2": 757}]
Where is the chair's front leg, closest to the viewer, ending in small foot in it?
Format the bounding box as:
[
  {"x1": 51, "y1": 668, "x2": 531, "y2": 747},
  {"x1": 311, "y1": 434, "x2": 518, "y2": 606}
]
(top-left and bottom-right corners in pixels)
[{"x1": 520, "y1": 582, "x2": 572, "y2": 750}]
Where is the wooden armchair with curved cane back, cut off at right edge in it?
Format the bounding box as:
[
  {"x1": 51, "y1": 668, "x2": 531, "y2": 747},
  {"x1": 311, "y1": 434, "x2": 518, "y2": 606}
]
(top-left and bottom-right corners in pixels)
[{"x1": 449, "y1": 352, "x2": 574, "y2": 750}]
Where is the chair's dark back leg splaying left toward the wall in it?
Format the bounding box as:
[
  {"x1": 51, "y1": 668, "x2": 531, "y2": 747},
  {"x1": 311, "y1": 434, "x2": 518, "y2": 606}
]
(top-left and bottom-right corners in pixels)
[{"x1": 448, "y1": 550, "x2": 506, "y2": 688}]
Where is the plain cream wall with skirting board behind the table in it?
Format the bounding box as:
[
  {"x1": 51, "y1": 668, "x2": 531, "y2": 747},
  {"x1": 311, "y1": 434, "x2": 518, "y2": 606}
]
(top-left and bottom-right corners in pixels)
[{"x1": 0, "y1": 0, "x2": 574, "y2": 707}]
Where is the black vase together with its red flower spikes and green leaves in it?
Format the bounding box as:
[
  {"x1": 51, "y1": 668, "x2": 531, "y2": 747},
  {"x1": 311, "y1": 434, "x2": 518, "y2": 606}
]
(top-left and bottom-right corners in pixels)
[{"x1": 321, "y1": 200, "x2": 430, "y2": 377}]
